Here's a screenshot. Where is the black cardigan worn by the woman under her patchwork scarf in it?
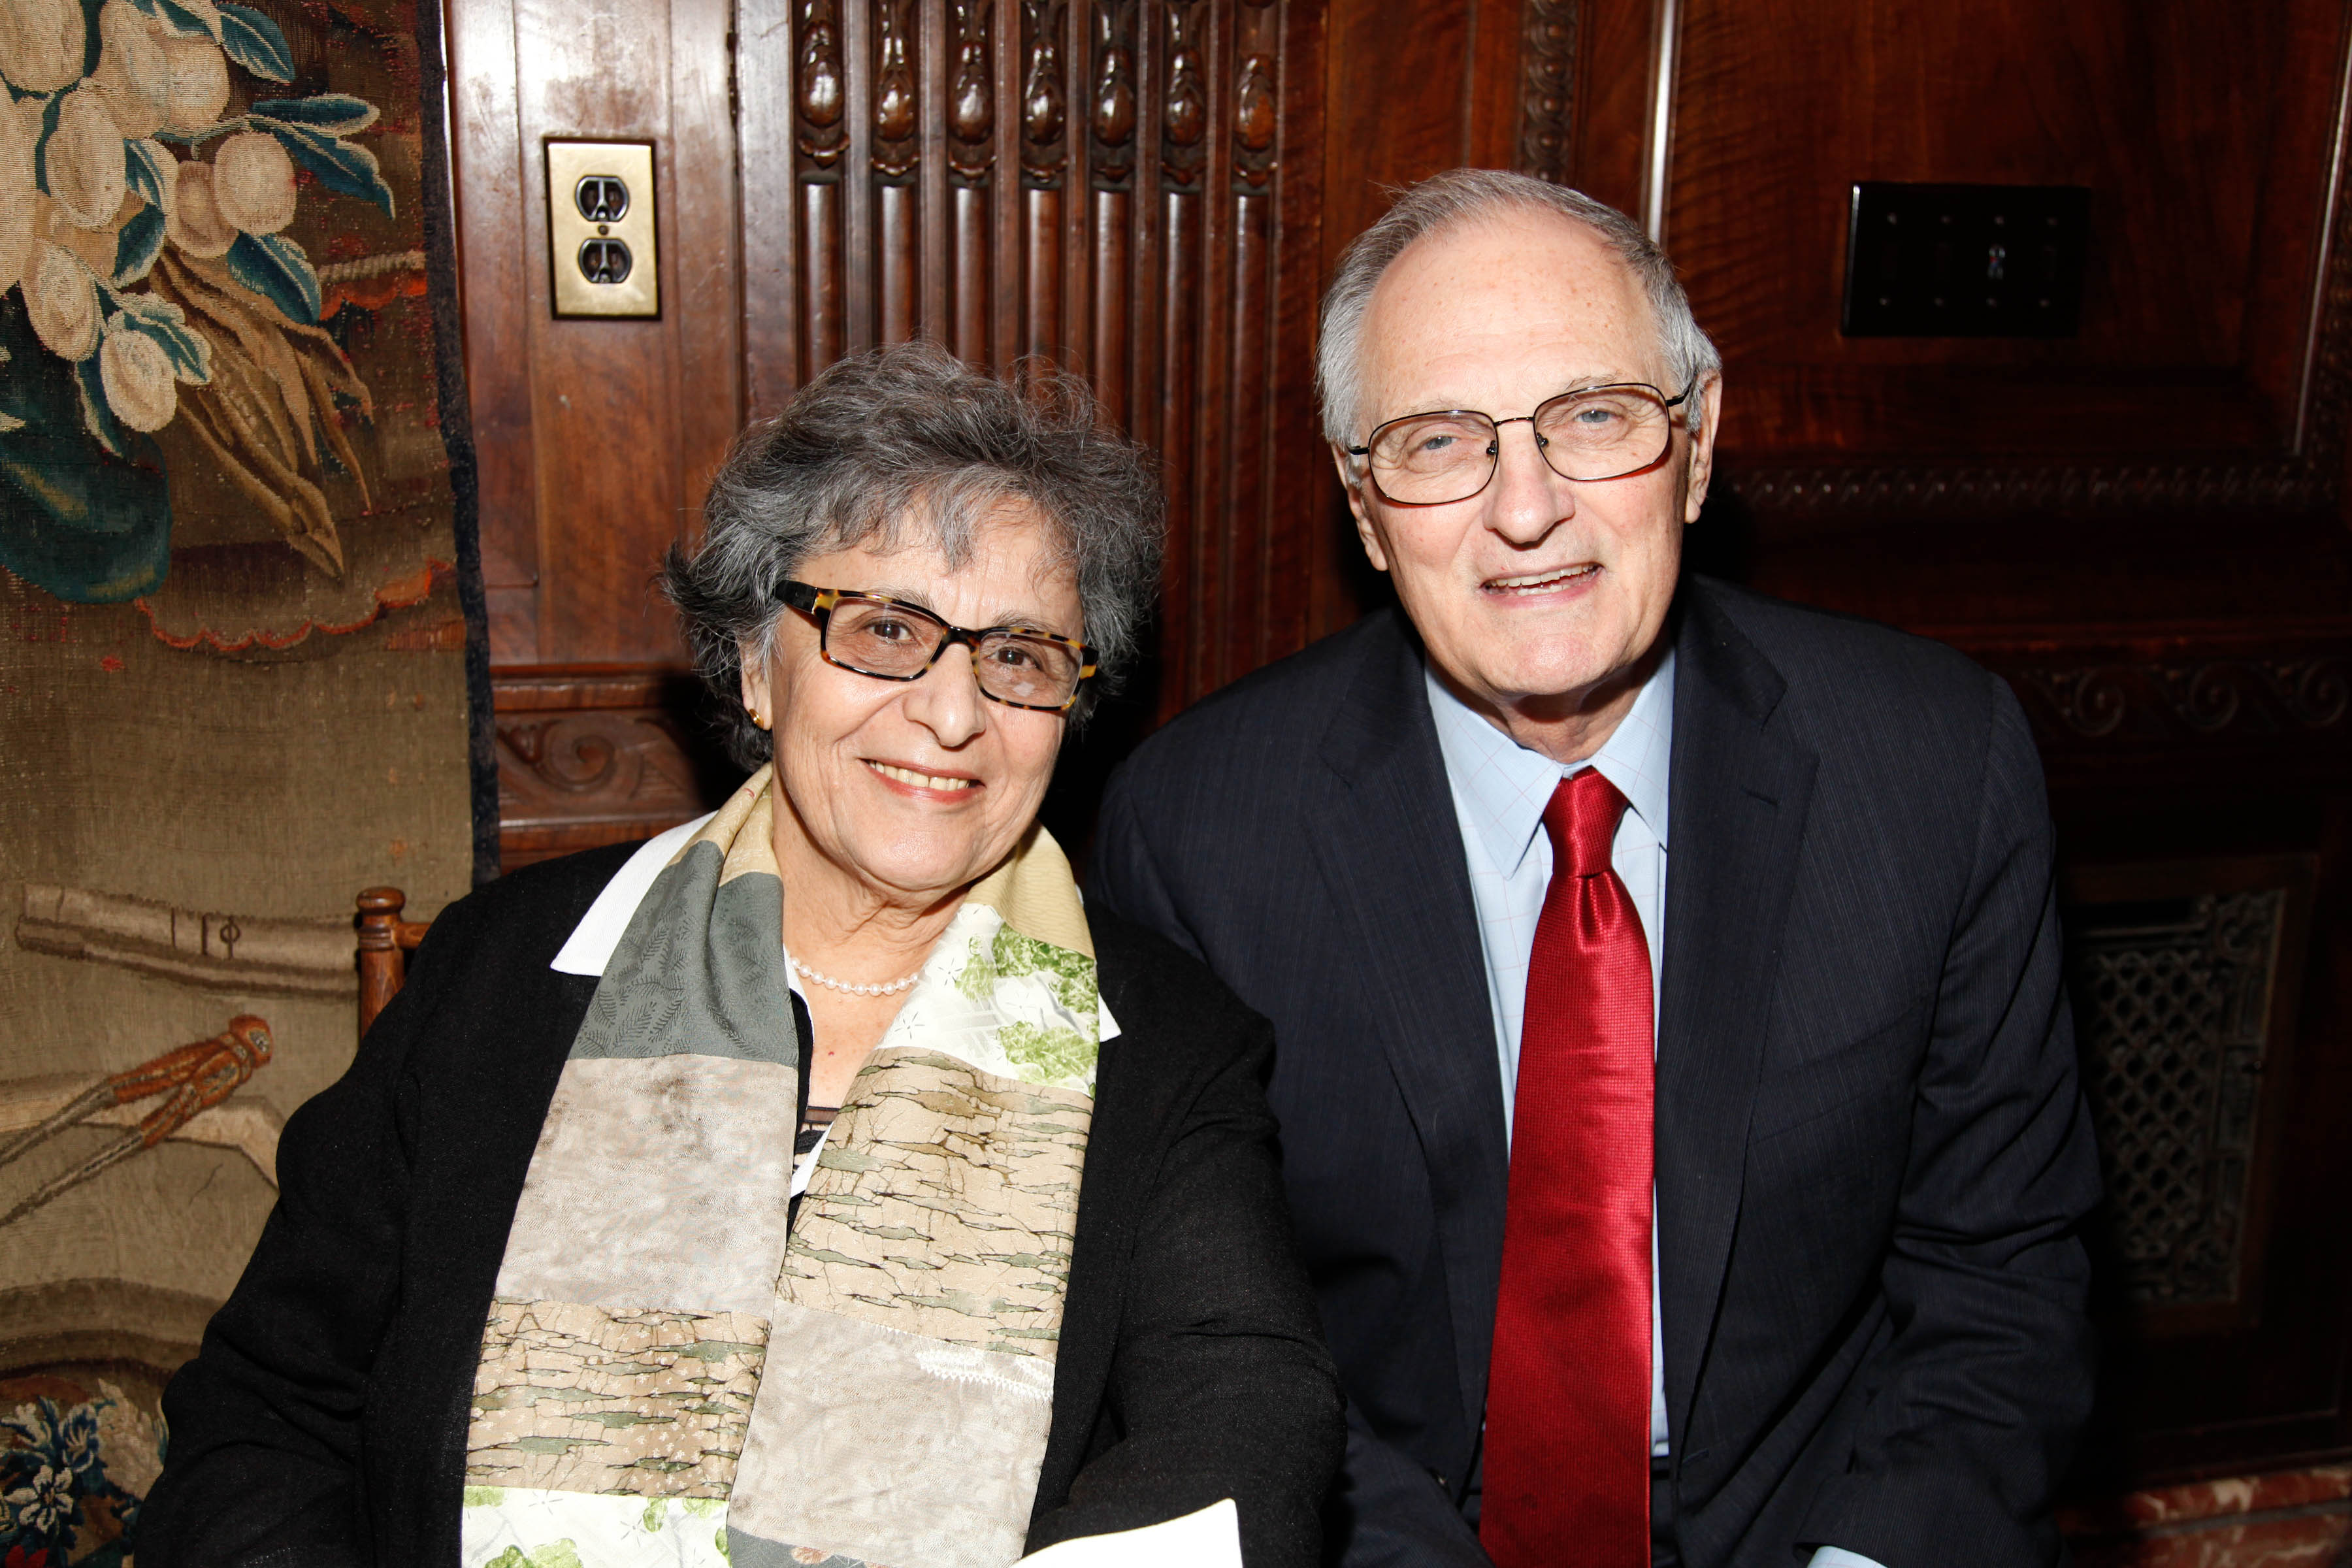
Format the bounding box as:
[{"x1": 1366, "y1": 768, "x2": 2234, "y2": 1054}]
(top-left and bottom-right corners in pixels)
[{"x1": 137, "y1": 846, "x2": 1343, "y2": 1568}]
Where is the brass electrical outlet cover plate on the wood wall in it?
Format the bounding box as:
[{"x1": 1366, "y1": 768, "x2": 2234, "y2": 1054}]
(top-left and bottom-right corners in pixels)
[{"x1": 546, "y1": 139, "x2": 661, "y2": 318}]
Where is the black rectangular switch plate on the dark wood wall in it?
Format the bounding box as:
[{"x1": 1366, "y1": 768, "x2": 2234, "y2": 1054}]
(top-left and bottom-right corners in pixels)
[{"x1": 1839, "y1": 181, "x2": 2091, "y2": 338}]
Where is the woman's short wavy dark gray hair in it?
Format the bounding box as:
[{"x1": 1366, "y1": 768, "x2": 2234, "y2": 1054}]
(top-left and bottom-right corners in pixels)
[{"x1": 661, "y1": 343, "x2": 1164, "y2": 769}]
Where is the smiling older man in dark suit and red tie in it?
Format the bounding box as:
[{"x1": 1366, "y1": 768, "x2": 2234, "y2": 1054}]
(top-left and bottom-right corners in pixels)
[{"x1": 1091, "y1": 172, "x2": 2098, "y2": 1568}]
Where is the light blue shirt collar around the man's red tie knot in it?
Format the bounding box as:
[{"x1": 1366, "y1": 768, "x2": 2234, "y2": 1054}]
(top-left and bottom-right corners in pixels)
[{"x1": 1426, "y1": 644, "x2": 1674, "y2": 877}]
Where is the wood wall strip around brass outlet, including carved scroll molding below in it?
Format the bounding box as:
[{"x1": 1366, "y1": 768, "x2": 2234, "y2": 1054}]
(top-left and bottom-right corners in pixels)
[{"x1": 444, "y1": 0, "x2": 743, "y2": 865}]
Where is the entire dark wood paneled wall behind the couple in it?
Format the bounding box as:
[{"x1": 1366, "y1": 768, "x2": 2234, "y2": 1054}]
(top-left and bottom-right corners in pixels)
[{"x1": 449, "y1": 0, "x2": 2352, "y2": 1486}]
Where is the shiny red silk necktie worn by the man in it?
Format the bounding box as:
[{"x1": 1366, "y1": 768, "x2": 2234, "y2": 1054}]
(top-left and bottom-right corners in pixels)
[{"x1": 1479, "y1": 769, "x2": 1656, "y2": 1568}]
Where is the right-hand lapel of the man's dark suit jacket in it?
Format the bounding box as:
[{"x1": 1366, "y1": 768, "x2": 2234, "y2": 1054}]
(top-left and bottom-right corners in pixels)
[{"x1": 1656, "y1": 578, "x2": 1816, "y2": 1458}]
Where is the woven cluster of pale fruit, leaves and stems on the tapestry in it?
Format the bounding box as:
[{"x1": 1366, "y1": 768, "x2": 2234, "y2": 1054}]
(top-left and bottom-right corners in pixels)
[{"x1": 0, "y1": 0, "x2": 393, "y2": 604}]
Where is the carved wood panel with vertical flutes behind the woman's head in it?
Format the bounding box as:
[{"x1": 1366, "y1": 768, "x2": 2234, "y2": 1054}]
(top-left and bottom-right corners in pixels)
[{"x1": 736, "y1": 0, "x2": 1329, "y2": 712}]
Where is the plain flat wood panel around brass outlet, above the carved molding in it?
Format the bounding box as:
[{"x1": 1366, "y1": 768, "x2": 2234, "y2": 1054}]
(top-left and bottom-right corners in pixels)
[{"x1": 447, "y1": 0, "x2": 743, "y2": 668}]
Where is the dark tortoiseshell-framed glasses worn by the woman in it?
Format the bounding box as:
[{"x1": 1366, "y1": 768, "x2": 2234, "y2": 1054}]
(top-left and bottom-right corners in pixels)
[{"x1": 776, "y1": 581, "x2": 1096, "y2": 712}]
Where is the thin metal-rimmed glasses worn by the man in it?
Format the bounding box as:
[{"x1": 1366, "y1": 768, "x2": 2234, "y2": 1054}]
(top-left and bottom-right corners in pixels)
[{"x1": 1348, "y1": 376, "x2": 1698, "y2": 506}]
